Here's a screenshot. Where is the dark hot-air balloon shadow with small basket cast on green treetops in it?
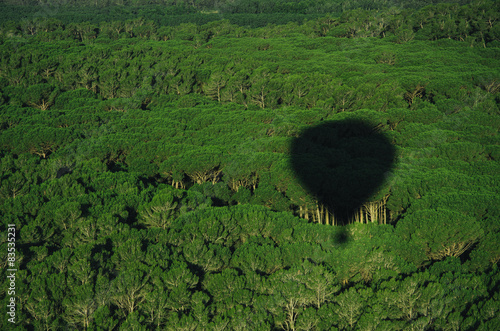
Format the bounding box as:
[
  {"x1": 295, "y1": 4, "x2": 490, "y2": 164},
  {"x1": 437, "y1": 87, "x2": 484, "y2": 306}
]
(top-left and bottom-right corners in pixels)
[{"x1": 291, "y1": 119, "x2": 395, "y2": 231}]
